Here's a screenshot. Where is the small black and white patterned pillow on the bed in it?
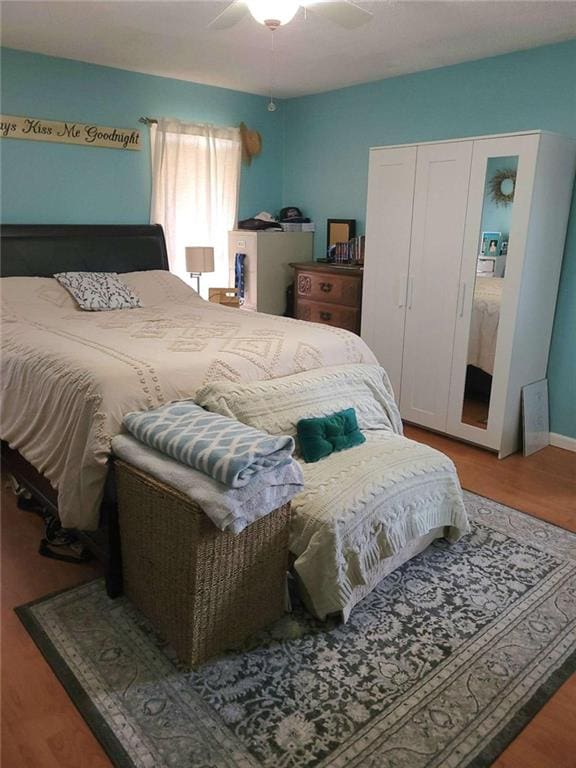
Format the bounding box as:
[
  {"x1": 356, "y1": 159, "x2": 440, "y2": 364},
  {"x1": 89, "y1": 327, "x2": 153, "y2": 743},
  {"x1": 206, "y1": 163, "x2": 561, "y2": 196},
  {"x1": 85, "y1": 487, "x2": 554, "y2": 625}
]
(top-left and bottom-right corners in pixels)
[{"x1": 54, "y1": 272, "x2": 142, "y2": 312}]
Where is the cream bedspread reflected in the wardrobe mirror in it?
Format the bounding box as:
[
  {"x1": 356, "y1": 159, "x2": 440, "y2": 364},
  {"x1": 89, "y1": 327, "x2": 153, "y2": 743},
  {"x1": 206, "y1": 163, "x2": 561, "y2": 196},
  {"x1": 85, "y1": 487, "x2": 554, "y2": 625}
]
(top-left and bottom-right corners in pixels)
[{"x1": 468, "y1": 277, "x2": 504, "y2": 375}]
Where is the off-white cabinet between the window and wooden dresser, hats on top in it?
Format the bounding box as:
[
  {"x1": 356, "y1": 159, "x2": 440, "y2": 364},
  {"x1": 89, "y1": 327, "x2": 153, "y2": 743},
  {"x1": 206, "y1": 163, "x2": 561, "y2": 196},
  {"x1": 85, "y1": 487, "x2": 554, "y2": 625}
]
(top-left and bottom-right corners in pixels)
[{"x1": 228, "y1": 229, "x2": 314, "y2": 315}]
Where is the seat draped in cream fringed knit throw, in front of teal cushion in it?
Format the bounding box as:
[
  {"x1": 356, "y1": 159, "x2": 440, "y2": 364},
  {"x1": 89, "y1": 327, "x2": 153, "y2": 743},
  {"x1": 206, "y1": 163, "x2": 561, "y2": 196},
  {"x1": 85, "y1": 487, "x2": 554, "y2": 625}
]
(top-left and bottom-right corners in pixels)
[{"x1": 290, "y1": 430, "x2": 469, "y2": 620}]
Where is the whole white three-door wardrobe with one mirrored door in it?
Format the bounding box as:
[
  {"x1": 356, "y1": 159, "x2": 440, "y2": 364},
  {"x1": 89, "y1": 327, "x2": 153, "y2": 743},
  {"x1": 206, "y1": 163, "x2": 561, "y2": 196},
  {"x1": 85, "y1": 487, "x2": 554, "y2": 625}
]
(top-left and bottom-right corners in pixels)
[{"x1": 362, "y1": 131, "x2": 576, "y2": 457}]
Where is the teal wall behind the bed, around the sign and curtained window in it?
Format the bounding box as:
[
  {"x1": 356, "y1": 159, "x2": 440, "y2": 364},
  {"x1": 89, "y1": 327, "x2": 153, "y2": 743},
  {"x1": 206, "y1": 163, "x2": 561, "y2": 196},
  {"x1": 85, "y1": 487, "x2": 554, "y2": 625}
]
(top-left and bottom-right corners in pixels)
[{"x1": 0, "y1": 48, "x2": 283, "y2": 224}]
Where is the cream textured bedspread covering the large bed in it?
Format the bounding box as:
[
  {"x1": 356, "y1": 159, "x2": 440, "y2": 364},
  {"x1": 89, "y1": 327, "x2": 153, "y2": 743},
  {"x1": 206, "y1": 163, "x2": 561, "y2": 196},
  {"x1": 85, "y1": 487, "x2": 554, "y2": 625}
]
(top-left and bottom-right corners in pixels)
[{"x1": 0, "y1": 271, "x2": 375, "y2": 530}]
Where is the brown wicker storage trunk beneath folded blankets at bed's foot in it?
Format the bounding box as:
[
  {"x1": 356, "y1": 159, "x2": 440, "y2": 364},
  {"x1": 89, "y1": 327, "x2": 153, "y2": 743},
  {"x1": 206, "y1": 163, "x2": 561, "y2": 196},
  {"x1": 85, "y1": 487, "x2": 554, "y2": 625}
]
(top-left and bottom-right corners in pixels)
[{"x1": 115, "y1": 460, "x2": 290, "y2": 667}]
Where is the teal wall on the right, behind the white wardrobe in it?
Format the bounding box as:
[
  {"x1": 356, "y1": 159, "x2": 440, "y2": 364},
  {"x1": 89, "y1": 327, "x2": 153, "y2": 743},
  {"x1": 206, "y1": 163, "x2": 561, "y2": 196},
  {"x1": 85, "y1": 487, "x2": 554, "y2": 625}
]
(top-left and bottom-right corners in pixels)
[{"x1": 283, "y1": 40, "x2": 576, "y2": 438}]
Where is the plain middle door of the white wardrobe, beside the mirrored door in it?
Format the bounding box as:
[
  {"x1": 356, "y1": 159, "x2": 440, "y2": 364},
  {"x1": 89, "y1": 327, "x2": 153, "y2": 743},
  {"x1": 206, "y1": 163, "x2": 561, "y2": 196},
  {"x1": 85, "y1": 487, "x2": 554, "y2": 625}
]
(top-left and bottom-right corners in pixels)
[{"x1": 400, "y1": 141, "x2": 473, "y2": 430}]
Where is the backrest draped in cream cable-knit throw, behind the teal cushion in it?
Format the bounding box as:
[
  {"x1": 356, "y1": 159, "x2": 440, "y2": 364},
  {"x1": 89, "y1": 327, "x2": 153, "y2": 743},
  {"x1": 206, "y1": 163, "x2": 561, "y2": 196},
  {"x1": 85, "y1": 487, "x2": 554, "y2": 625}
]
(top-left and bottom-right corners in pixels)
[{"x1": 194, "y1": 364, "x2": 402, "y2": 437}]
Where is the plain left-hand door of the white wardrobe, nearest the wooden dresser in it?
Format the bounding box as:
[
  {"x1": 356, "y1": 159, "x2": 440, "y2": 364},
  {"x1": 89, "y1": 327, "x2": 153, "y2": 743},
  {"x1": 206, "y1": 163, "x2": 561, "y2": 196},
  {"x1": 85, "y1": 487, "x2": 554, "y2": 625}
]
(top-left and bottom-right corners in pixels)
[{"x1": 362, "y1": 147, "x2": 417, "y2": 398}]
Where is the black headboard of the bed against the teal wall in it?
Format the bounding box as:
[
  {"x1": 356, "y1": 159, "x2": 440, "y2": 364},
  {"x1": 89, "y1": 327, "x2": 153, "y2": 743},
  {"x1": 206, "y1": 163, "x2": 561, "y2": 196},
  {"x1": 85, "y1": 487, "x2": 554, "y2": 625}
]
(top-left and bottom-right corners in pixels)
[{"x1": 0, "y1": 224, "x2": 168, "y2": 277}]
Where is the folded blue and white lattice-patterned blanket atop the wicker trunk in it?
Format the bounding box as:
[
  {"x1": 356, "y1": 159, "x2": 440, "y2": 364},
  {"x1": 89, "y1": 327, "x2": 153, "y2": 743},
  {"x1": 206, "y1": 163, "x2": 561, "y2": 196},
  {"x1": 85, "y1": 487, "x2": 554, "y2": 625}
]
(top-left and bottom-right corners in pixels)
[{"x1": 123, "y1": 400, "x2": 294, "y2": 488}]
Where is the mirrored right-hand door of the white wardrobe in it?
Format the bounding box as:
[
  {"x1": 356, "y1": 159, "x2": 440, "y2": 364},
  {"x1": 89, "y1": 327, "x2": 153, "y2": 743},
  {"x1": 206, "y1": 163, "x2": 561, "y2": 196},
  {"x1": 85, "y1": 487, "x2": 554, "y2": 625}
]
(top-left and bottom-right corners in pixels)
[{"x1": 447, "y1": 134, "x2": 546, "y2": 450}]
